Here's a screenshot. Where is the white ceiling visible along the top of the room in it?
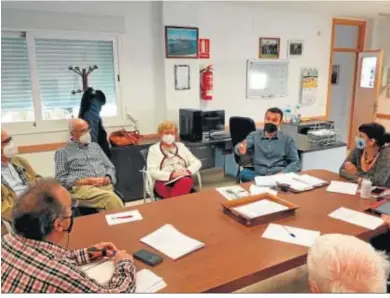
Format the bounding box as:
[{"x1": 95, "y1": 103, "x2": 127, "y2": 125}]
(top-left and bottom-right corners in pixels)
[{"x1": 1, "y1": 0, "x2": 390, "y2": 18}]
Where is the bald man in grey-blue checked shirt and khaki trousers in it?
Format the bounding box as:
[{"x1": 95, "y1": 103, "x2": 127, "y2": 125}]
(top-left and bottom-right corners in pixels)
[{"x1": 55, "y1": 119, "x2": 124, "y2": 210}]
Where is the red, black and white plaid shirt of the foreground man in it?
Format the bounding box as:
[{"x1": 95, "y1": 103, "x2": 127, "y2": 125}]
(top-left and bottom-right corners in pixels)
[{"x1": 1, "y1": 234, "x2": 135, "y2": 293}]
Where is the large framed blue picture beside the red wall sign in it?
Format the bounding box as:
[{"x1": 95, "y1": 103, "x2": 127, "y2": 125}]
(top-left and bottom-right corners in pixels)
[{"x1": 165, "y1": 26, "x2": 199, "y2": 59}]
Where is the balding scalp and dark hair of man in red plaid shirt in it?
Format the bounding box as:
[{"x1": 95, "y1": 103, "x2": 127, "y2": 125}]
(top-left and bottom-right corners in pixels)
[{"x1": 12, "y1": 179, "x2": 65, "y2": 240}]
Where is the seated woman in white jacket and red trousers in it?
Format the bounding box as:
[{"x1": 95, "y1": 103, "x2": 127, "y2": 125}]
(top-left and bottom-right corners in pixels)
[{"x1": 147, "y1": 120, "x2": 202, "y2": 199}]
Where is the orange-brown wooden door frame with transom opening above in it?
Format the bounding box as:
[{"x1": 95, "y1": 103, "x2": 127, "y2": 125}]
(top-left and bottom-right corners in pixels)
[{"x1": 326, "y1": 18, "x2": 367, "y2": 149}]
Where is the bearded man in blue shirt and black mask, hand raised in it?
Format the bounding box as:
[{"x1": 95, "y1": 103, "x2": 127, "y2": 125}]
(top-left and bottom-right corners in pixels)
[{"x1": 234, "y1": 108, "x2": 301, "y2": 182}]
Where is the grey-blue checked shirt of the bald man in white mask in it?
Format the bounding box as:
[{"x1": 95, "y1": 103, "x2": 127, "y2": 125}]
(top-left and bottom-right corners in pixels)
[{"x1": 55, "y1": 141, "x2": 116, "y2": 189}]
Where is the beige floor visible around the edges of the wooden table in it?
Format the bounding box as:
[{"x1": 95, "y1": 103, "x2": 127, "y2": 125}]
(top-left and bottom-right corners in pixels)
[{"x1": 126, "y1": 178, "x2": 309, "y2": 293}]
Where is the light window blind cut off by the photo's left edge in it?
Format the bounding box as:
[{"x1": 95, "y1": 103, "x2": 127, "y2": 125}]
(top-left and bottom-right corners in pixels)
[{"x1": 1, "y1": 36, "x2": 34, "y2": 122}]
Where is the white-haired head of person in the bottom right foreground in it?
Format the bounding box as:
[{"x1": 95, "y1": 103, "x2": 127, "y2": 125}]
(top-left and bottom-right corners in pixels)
[{"x1": 307, "y1": 234, "x2": 390, "y2": 293}]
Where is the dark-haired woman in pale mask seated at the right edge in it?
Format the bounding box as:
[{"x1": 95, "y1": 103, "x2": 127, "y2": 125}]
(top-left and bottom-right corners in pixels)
[{"x1": 340, "y1": 123, "x2": 390, "y2": 188}]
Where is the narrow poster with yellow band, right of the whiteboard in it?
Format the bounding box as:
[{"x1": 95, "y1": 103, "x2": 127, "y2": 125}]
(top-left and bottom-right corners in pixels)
[{"x1": 300, "y1": 68, "x2": 318, "y2": 106}]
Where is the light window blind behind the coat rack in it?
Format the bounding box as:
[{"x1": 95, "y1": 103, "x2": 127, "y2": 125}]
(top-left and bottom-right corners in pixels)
[{"x1": 35, "y1": 38, "x2": 116, "y2": 120}]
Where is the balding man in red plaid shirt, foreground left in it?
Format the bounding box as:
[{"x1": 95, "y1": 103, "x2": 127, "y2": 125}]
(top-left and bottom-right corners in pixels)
[{"x1": 1, "y1": 180, "x2": 135, "y2": 293}]
